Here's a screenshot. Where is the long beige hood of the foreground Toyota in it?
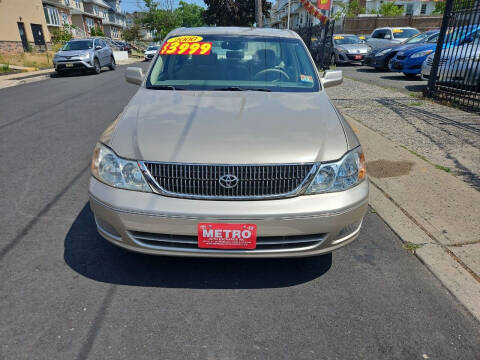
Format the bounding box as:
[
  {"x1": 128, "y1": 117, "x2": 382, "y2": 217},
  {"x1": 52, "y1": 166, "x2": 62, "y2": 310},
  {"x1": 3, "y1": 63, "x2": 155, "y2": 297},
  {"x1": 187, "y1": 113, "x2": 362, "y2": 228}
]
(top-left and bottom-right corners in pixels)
[{"x1": 108, "y1": 88, "x2": 347, "y2": 164}]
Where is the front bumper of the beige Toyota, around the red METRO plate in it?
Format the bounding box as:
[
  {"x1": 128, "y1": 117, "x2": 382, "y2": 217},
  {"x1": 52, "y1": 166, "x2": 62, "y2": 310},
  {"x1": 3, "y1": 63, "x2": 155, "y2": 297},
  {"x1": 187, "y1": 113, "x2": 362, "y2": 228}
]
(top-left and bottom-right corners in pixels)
[{"x1": 89, "y1": 177, "x2": 368, "y2": 257}]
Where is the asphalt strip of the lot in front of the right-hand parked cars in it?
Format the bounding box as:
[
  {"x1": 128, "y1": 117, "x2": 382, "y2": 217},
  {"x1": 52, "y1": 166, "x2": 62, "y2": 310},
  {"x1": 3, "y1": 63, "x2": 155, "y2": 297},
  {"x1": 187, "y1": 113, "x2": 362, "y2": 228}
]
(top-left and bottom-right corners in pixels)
[{"x1": 337, "y1": 65, "x2": 427, "y2": 96}]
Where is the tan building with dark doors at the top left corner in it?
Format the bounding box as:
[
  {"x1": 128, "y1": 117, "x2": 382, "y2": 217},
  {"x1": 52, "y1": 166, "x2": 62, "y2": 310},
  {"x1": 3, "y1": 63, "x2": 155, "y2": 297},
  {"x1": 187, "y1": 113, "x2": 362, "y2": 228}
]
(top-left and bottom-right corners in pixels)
[{"x1": 0, "y1": 0, "x2": 50, "y2": 52}]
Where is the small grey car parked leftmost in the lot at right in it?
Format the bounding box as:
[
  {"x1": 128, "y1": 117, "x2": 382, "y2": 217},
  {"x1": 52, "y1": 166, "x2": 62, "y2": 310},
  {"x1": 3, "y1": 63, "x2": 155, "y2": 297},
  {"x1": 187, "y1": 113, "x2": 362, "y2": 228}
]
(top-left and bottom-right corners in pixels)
[{"x1": 330, "y1": 34, "x2": 372, "y2": 64}]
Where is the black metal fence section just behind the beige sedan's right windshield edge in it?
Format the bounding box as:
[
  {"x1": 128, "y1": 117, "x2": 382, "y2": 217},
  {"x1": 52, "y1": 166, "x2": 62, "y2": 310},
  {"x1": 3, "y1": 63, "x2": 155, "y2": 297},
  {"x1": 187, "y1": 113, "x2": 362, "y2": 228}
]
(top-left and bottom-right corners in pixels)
[{"x1": 294, "y1": 20, "x2": 335, "y2": 69}]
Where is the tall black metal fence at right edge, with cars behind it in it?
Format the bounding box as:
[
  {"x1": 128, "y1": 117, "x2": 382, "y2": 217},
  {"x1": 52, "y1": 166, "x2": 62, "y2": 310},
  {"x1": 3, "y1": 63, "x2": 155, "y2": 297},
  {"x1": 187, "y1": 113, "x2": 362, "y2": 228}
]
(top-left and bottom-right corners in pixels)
[{"x1": 430, "y1": 0, "x2": 480, "y2": 112}]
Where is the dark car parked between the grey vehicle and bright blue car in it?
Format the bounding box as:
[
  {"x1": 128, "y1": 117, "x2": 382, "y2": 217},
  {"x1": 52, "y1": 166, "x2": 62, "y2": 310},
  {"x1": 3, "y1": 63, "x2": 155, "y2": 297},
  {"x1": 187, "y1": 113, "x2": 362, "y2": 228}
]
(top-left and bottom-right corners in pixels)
[{"x1": 364, "y1": 30, "x2": 439, "y2": 70}]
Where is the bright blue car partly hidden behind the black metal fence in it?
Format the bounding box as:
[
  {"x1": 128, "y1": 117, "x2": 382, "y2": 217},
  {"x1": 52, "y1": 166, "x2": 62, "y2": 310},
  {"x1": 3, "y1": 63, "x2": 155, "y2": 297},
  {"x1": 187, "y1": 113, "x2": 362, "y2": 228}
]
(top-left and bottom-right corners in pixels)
[{"x1": 388, "y1": 25, "x2": 480, "y2": 78}]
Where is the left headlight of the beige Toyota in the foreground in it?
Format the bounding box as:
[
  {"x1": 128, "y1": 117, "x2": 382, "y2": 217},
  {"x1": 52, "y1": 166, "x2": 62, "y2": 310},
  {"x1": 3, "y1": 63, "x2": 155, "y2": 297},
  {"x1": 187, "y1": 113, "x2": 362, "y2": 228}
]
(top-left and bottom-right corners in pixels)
[{"x1": 92, "y1": 143, "x2": 152, "y2": 192}]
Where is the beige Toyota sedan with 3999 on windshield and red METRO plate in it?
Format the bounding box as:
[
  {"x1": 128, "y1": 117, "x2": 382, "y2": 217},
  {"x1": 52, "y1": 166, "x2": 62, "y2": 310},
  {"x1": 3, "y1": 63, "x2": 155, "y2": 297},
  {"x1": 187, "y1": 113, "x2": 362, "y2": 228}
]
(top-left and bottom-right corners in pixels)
[{"x1": 89, "y1": 27, "x2": 368, "y2": 257}]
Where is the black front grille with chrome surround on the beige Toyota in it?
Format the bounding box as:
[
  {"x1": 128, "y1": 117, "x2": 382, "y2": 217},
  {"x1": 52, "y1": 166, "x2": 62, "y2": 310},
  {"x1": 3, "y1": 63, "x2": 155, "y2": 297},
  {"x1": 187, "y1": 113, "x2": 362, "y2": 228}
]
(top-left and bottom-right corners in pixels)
[{"x1": 142, "y1": 162, "x2": 314, "y2": 200}]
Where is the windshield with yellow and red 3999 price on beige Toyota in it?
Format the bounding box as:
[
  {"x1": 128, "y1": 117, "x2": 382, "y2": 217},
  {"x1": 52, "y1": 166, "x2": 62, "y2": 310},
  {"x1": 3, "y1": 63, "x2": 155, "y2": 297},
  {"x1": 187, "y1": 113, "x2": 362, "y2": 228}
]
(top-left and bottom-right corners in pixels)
[{"x1": 147, "y1": 35, "x2": 319, "y2": 92}]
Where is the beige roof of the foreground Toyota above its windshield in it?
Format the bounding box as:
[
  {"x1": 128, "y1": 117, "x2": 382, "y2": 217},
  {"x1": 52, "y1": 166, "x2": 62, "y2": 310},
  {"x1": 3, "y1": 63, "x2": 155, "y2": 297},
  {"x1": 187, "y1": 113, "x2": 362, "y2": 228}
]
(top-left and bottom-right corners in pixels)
[{"x1": 168, "y1": 26, "x2": 300, "y2": 39}]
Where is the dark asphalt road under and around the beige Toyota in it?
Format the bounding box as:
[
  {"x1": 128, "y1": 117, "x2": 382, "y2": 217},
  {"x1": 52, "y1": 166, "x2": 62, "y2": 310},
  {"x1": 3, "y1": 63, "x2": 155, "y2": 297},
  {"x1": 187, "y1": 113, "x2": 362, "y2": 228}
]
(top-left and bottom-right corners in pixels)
[{"x1": 0, "y1": 64, "x2": 480, "y2": 359}]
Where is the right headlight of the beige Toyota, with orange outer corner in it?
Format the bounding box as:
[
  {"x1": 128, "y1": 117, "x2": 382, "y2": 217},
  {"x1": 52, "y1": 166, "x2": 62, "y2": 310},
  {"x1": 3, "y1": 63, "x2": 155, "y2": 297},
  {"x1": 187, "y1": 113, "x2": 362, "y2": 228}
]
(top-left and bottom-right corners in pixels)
[{"x1": 306, "y1": 147, "x2": 367, "y2": 194}]
